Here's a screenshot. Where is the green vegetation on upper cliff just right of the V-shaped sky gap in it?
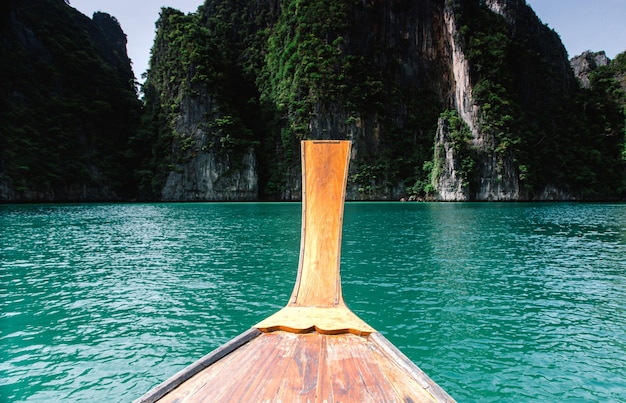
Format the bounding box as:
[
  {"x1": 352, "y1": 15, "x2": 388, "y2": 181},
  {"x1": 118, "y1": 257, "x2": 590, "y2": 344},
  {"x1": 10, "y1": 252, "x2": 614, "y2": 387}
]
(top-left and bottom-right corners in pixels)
[{"x1": 138, "y1": 1, "x2": 263, "y2": 197}]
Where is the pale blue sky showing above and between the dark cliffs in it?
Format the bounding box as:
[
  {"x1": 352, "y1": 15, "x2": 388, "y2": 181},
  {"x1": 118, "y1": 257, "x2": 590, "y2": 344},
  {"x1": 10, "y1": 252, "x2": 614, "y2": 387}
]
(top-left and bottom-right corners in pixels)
[{"x1": 70, "y1": 0, "x2": 626, "y2": 82}]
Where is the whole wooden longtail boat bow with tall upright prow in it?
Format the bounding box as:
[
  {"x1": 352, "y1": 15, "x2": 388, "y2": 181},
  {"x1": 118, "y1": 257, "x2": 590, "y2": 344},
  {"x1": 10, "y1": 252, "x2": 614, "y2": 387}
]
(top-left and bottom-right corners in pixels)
[{"x1": 135, "y1": 140, "x2": 454, "y2": 403}]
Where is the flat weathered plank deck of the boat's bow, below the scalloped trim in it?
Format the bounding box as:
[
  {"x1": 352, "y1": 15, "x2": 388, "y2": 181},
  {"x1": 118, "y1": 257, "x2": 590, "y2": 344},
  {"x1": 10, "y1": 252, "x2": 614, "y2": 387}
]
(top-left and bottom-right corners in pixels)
[{"x1": 151, "y1": 331, "x2": 454, "y2": 403}]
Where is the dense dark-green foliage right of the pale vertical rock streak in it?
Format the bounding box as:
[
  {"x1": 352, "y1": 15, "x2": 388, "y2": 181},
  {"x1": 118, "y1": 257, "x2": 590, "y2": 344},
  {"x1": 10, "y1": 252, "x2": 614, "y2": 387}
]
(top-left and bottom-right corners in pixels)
[{"x1": 459, "y1": 1, "x2": 626, "y2": 198}]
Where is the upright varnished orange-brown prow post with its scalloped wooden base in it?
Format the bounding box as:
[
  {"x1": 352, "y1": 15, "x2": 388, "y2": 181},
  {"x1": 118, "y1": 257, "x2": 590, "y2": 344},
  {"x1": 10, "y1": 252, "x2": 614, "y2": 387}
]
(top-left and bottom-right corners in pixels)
[{"x1": 255, "y1": 141, "x2": 374, "y2": 335}]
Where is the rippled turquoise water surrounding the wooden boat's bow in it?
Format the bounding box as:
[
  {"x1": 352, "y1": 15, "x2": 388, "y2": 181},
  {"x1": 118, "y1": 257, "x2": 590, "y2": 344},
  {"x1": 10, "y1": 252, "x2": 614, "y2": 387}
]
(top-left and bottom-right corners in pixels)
[{"x1": 0, "y1": 203, "x2": 626, "y2": 402}]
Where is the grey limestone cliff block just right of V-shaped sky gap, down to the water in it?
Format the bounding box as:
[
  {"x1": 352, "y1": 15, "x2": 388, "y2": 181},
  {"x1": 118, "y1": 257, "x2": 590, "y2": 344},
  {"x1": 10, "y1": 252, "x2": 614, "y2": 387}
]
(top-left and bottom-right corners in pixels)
[{"x1": 144, "y1": 6, "x2": 258, "y2": 201}]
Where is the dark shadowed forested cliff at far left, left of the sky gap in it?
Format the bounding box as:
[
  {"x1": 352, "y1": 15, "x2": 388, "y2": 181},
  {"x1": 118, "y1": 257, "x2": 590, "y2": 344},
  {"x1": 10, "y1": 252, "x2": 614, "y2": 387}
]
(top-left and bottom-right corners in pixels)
[{"x1": 0, "y1": 0, "x2": 140, "y2": 200}]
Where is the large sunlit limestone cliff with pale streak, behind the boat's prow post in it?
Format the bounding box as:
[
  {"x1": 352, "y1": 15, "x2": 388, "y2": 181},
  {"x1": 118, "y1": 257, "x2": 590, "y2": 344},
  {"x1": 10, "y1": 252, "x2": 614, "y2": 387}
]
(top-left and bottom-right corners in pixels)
[{"x1": 148, "y1": 0, "x2": 624, "y2": 201}]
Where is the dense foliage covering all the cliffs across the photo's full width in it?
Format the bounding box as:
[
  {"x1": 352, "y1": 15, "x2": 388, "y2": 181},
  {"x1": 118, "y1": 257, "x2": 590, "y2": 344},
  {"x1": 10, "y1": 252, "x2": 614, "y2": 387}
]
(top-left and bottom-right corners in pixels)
[{"x1": 0, "y1": 0, "x2": 626, "y2": 200}]
